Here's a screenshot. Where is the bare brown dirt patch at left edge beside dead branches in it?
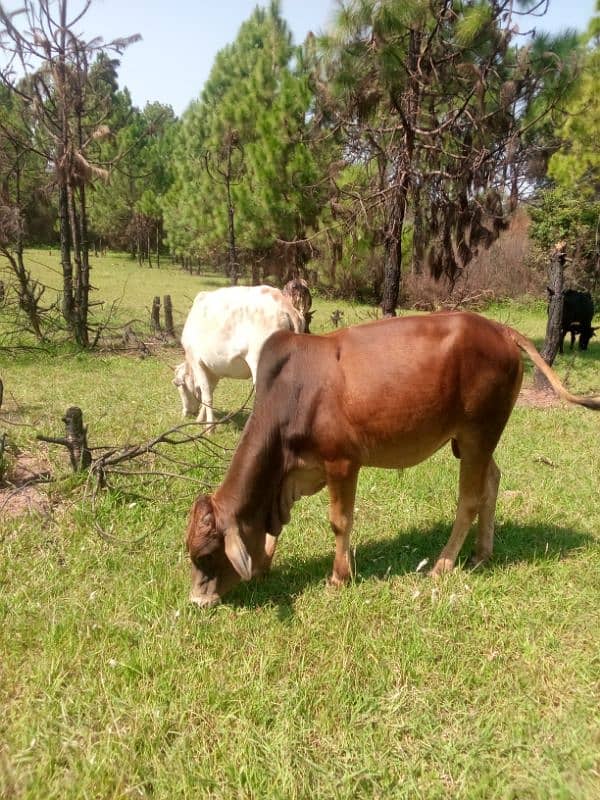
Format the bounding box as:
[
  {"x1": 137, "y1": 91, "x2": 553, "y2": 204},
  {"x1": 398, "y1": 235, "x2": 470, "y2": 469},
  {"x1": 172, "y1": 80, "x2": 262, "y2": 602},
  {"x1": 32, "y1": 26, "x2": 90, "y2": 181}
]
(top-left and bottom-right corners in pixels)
[{"x1": 0, "y1": 453, "x2": 50, "y2": 517}]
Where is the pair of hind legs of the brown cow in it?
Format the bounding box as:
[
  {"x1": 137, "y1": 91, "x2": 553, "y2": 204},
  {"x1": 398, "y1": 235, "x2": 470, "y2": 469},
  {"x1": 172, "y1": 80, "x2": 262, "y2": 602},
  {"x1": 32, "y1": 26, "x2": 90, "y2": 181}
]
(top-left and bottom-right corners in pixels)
[{"x1": 430, "y1": 454, "x2": 500, "y2": 576}]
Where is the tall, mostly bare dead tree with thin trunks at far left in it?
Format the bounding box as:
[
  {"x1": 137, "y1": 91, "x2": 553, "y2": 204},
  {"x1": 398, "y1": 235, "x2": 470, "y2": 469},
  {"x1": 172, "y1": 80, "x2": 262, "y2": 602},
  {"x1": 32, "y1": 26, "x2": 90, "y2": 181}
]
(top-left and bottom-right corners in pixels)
[{"x1": 0, "y1": 0, "x2": 139, "y2": 347}]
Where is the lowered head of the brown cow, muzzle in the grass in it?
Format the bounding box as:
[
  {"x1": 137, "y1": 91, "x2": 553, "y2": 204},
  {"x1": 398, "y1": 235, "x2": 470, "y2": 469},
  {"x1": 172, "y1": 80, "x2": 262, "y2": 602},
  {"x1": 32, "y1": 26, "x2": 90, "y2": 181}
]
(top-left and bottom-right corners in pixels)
[{"x1": 187, "y1": 494, "x2": 266, "y2": 607}]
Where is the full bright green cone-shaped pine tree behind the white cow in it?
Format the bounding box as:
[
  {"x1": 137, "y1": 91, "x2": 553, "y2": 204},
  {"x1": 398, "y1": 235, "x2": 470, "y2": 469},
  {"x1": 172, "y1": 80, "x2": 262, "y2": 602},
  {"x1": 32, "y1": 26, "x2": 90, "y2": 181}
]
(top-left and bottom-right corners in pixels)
[{"x1": 165, "y1": 2, "x2": 326, "y2": 280}]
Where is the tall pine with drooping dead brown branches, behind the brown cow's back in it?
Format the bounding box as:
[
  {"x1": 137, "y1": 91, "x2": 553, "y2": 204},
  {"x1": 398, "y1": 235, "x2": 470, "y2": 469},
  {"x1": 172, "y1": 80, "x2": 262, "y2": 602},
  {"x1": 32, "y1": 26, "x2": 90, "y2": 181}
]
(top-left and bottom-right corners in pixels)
[{"x1": 317, "y1": 0, "x2": 573, "y2": 315}]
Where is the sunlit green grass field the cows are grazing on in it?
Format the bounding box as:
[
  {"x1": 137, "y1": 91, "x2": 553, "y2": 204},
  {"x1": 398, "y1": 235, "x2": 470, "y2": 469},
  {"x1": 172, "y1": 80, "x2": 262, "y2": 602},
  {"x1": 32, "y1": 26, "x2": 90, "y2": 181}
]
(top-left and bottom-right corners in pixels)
[{"x1": 0, "y1": 251, "x2": 600, "y2": 800}]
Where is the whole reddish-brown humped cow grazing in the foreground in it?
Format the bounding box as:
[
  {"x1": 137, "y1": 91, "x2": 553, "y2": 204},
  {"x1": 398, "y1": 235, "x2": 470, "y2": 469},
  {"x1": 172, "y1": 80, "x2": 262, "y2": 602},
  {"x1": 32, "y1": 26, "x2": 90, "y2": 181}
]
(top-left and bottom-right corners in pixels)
[{"x1": 187, "y1": 312, "x2": 600, "y2": 606}]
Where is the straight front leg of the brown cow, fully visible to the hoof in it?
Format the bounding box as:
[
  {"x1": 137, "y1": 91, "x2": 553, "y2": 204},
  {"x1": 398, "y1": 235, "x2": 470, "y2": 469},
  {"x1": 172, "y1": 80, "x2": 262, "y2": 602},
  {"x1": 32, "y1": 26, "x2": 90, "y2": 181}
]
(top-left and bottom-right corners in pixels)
[{"x1": 326, "y1": 462, "x2": 358, "y2": 586}]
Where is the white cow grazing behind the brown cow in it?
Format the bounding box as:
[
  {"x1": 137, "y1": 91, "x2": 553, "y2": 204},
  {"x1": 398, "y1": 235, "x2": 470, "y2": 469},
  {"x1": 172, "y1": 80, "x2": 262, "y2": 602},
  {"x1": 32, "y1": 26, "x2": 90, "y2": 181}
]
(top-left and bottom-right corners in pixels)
[{"x1": 173, "y1": 286, "x2": 304, "y2": 424}]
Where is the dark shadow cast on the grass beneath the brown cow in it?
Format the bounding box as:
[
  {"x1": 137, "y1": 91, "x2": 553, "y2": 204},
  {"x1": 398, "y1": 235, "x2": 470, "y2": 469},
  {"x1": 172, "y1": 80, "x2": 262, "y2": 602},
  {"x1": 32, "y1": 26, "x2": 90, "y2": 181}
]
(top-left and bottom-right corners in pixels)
[{"x1": 225, "y1": 523, "x2": 595, "y2": 619}]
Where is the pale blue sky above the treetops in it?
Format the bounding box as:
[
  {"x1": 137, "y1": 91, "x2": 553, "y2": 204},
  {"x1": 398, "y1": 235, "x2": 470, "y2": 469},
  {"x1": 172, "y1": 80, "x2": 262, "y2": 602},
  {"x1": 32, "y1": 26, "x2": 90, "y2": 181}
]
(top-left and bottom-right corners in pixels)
[{"x1": 4, "y1": 0, "x2": 596, "y2": 115}]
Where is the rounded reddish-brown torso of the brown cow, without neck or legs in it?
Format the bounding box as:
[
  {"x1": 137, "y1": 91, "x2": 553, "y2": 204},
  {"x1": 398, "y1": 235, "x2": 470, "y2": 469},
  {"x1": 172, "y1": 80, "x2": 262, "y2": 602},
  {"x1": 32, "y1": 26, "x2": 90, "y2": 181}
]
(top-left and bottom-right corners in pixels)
[{"x1": 256, "y1": 312, "x2": 522, "y2": 467}]
